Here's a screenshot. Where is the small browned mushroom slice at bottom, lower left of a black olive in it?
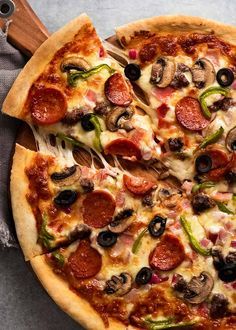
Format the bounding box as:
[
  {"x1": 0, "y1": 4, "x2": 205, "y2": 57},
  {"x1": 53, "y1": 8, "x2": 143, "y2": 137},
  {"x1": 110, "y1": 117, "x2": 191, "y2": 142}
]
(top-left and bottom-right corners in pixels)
[{"x1": 104, "y1": 273, "x2": 132, "y2": 296}]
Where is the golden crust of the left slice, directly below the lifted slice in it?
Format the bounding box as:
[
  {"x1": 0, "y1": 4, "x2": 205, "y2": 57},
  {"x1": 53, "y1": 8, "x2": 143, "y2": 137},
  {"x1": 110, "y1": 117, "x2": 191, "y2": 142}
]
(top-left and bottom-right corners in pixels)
[{"x1": 10, "y1": 144, "x2": 43, "y2": 260}]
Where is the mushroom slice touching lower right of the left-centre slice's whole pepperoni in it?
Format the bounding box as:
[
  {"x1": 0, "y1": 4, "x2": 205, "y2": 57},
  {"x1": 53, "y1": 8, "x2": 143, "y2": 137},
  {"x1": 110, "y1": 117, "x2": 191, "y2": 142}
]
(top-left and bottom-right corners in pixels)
[{"x1": 108, "y1": 209, "x2": 134, "y2": 234}]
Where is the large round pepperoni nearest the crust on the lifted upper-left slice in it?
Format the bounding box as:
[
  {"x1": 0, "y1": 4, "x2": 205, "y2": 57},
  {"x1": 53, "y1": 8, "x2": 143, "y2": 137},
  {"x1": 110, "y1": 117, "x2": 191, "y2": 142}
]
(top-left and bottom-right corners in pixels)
[{"x1": 30, "y1": 88, "x2": 67, "y2": 125}]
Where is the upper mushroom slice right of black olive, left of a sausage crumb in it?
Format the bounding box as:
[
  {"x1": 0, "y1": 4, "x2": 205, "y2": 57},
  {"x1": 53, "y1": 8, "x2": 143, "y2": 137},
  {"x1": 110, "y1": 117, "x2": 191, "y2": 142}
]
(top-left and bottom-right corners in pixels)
[{"x1": 150, "y1": 57, "x2": 175, "y2": 88}]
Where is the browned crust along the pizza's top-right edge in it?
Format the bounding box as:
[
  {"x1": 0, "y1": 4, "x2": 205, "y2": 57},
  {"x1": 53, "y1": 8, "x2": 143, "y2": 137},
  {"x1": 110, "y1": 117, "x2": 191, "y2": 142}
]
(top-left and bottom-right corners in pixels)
[{"x1": 116, "y1": 15, "x2": 236, "y2": 45}]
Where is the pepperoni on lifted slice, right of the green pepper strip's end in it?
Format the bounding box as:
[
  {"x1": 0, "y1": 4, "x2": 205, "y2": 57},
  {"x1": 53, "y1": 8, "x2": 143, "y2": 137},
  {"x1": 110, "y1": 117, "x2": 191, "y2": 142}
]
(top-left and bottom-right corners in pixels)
[{"x1": 105, "y1": 73, "x2": 132, "y2": 107}]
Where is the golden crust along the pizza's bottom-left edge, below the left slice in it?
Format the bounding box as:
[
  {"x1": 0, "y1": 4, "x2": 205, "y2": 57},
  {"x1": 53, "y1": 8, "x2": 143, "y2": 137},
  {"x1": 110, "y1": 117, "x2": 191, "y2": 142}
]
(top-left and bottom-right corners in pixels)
[{"x1": 30, "y1": 256, "x2": 130, "y2": 330}]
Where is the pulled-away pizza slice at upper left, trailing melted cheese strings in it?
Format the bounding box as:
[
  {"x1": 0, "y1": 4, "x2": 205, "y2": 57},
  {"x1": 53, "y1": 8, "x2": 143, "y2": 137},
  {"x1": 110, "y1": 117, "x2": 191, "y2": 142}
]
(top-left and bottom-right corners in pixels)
[{"x1": 3, "y1": 14, "x2": 160, "y2": 160}]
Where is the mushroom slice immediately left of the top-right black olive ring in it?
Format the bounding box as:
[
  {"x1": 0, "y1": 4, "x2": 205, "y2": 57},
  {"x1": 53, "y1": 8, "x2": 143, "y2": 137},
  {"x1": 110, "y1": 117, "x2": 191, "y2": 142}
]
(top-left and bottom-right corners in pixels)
[{"x1": 191, "y1": 58, "x2": 216, "y2": 88}]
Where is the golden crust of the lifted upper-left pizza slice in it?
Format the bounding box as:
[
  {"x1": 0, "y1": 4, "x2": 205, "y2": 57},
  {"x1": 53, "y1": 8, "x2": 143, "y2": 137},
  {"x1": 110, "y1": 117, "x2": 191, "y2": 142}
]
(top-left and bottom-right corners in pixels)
[{"x1": 2, "y1": 14, "x2": 92, "y2": 119}]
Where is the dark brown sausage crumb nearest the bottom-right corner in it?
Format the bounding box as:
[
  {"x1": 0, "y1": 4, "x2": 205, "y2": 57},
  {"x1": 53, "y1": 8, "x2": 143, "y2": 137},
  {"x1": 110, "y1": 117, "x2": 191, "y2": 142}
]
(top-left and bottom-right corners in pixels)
[{"x1": 210, "y1": 293, "x2": 229, "y2": 319}]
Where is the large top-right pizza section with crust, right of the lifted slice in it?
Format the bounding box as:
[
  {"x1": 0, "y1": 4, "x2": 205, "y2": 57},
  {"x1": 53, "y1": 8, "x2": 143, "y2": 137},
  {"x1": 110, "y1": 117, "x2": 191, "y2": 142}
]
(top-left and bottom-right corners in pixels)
[{"x1": 116, "y1": 16, "x2": 236, "y2": 183}]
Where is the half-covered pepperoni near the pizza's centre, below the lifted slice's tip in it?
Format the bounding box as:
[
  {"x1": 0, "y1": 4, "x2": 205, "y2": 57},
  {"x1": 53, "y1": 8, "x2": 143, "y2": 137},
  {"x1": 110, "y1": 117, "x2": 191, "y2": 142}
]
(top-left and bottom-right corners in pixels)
[{"x1": 123, "y1": 174, "x2": 156, "y2": 196}]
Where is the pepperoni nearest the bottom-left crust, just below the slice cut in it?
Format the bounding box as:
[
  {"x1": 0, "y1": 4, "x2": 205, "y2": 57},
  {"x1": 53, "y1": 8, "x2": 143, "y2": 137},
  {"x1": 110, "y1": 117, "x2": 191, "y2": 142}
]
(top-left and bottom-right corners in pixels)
[{"x1": 67, "y1": 240, "x2": 102, "y2": 279}]
